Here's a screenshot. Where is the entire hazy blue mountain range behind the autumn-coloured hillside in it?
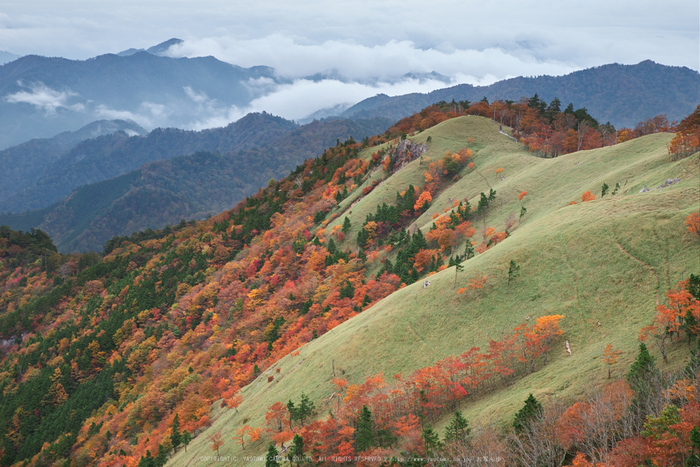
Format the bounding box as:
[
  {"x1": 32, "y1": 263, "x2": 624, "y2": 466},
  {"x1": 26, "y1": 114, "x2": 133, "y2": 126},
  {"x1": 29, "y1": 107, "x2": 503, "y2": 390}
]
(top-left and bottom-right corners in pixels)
[{"x1": 0, "y1": 39, "x2": 700, "y2": 251}]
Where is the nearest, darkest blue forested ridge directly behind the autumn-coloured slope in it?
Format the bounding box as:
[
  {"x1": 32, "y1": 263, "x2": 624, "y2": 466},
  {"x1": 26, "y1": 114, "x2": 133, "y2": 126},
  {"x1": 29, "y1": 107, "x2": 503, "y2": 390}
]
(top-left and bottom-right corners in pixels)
[{"x1": 0, "y1": 114, "x2": 389, "y2": 252}]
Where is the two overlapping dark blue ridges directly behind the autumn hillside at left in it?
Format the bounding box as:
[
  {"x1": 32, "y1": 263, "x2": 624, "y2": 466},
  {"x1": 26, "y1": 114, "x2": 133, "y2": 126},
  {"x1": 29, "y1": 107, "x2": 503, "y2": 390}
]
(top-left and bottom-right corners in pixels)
[{"x1": 0, "y1": 114, "x2": 392, "y2": 252}]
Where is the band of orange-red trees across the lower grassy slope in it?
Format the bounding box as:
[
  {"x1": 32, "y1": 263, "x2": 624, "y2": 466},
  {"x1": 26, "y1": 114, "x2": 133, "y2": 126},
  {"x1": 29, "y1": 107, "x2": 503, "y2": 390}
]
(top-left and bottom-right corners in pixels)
[{"x1": 254, "y1": 315, "x2": 563, "y2": 458}]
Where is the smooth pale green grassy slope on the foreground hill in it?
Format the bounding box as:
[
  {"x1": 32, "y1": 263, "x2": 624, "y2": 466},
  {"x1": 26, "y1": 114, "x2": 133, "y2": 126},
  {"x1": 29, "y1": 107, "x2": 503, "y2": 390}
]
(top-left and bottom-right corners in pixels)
[{"x1": 170, "y1": 117, "x2": 700, "y2": 465}]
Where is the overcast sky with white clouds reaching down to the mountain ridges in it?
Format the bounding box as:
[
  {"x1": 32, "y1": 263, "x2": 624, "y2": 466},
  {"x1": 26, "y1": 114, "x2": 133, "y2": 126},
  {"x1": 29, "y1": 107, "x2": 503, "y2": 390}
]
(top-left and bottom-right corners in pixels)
[{"x1": 0, "y1": 0, "x2": 700, "y2": 122}]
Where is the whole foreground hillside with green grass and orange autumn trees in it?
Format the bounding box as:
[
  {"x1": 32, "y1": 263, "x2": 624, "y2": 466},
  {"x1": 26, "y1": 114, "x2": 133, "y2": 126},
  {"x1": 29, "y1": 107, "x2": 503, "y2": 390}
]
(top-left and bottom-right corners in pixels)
[{"x1": 0, "y1": 100, "x2": 700, "y2": 466}]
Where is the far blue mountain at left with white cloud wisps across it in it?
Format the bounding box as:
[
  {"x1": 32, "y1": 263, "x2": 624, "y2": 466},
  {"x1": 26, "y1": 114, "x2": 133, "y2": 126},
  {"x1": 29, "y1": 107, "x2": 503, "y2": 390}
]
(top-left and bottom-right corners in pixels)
[{"x1": 0, "y1": 52, "x2": 277, "y2": 148}]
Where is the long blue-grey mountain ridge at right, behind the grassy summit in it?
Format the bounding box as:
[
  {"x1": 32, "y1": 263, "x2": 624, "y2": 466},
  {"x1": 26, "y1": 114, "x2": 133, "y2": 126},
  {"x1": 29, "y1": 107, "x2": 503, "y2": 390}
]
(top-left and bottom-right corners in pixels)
[{"x1": 342, "y1": 60, "x2": 700, "y2": 127}]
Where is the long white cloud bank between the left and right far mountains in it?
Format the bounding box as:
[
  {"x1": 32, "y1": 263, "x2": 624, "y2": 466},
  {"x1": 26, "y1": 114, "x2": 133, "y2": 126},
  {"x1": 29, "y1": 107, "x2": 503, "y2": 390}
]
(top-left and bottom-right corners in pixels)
[{"x1": 168, "y1": 34, "x2": 578, "y2": 81}]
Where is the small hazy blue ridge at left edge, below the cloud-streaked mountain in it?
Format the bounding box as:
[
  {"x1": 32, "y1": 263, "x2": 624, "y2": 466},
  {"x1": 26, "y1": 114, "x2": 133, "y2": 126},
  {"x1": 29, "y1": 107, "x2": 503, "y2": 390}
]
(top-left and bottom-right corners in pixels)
[{"x1": 0, "y1": 120, "x2": 146, "y2": 200}]
